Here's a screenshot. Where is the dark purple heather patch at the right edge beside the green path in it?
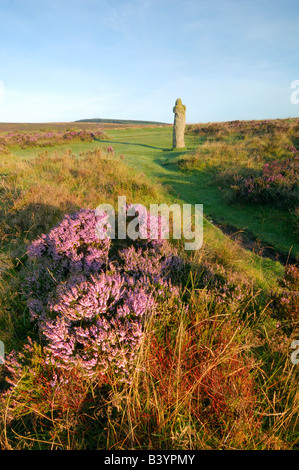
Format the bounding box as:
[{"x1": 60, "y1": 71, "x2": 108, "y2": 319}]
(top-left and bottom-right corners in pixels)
[{"x1": 233, "y1": 156, "x2": 299, "y2": 206}]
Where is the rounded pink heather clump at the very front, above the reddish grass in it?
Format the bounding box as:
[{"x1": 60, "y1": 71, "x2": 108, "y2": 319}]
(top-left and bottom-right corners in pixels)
[{"x1": 41, "y1": 272, "x2": 155, "y2": 380}]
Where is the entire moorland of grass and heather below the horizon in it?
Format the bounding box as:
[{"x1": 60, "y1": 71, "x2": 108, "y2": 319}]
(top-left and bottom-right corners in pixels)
[{"x1": 0, "y1": 119, "x2": 299, "y2": 450}]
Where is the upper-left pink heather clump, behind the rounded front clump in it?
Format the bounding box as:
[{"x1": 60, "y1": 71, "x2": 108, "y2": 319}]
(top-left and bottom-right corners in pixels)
[{"x1": 24, "y1": 209, "x2": 110, "y2": 324}]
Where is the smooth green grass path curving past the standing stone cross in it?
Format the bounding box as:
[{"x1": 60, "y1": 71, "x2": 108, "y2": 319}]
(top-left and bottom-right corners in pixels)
[{"x1": 102, "y1": 128, "x2": 299, "y2": 256}]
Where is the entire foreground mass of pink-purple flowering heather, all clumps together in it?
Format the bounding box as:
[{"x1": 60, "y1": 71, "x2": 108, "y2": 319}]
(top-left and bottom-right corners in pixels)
[{"x1": 19, "y1": 206, "x2": 183, "y2": 382}]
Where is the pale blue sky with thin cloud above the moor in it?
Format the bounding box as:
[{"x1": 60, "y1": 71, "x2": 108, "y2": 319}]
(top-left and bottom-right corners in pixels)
[{"x1": 0, "y1": 0, "x2": 299, "y2": 123}]
